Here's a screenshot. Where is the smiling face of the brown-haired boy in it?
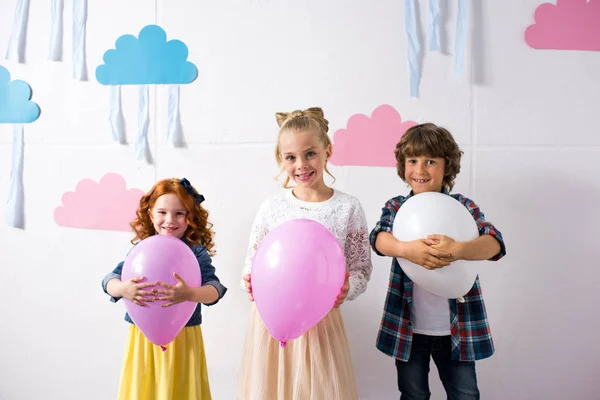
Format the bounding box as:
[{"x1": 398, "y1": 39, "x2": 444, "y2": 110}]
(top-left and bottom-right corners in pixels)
[{"x1": 404, "y1": 156, "x2": 446, "y2": 194}]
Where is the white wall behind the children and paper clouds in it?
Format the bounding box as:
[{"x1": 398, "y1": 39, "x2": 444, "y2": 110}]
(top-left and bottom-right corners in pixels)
[{"x1": 0, "y1": 0, "x2": 600, "y2": 400}]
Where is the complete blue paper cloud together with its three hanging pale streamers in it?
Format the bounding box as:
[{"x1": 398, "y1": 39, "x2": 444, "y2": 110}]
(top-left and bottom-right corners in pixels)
[{"x1": 96, "y1": 25, "x2": 198, "y2": 163}]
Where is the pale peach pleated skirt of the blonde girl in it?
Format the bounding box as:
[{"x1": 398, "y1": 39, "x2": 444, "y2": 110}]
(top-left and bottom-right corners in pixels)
[{"x1": 237, "y1": 304, "x2": 358, "y2": 400}]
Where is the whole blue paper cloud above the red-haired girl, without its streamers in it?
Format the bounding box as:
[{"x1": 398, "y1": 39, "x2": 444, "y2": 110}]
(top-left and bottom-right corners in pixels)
[{"x1": 96, "y1": 25, "x2": 198, "y2": 85}]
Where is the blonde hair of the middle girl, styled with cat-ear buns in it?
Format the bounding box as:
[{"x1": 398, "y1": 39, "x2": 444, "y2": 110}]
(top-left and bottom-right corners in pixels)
[{"x1": 275, "y1": 107, "x2": 335, "y2": 189}]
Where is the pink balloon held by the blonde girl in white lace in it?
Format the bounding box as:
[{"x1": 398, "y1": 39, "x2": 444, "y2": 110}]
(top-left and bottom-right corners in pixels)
[{"x1": 251, "y1": 219, "x2": 346, "y2": 346}]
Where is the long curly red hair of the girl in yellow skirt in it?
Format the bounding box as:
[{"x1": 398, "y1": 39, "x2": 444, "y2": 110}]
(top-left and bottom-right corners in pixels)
[{"x1": 130, "y1": 178, "x2": 215, "y2": 256}]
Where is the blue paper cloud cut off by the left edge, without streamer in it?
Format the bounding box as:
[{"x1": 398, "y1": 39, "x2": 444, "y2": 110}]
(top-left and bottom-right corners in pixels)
[{"x1": 0, "y1": 66, "x2": 40, "y2": 124}]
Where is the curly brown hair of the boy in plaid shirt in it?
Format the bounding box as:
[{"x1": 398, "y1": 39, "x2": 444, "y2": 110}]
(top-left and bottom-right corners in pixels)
[{"x1": 394, "y1": 123, "x2": 463, "y2": 191}]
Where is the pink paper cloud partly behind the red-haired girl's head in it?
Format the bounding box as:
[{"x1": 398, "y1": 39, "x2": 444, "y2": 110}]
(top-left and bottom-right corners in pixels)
[{"x1": 54, "y1": 173, "x2": 144, "y2": 232}]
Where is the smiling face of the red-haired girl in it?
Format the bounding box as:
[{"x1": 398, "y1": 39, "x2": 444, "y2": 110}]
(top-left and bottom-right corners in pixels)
[{"x1": 150, "y1": 193, "x2": 188, "y2": 239}]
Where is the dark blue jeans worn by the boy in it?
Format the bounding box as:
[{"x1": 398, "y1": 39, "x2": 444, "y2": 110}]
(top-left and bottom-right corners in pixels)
[{"x1": 396, "y1": 334, "x2": 479, "y2": 400}]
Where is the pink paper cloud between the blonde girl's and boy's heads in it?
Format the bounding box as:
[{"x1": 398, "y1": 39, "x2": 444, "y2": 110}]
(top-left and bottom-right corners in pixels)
[{"x1": 331, "y1": 104, "x2": 417, "y2": 167}]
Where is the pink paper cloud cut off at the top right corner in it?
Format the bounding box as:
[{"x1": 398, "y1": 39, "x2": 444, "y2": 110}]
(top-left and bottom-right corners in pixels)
[{"x1": 525, "y1": 0, "x2": 600, "y2": 51}]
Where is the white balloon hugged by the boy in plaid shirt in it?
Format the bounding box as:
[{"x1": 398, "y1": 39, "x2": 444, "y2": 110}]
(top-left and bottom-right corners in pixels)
[{"x1": 393, "y1": 192, "x2": 479, "y2": 299}]
